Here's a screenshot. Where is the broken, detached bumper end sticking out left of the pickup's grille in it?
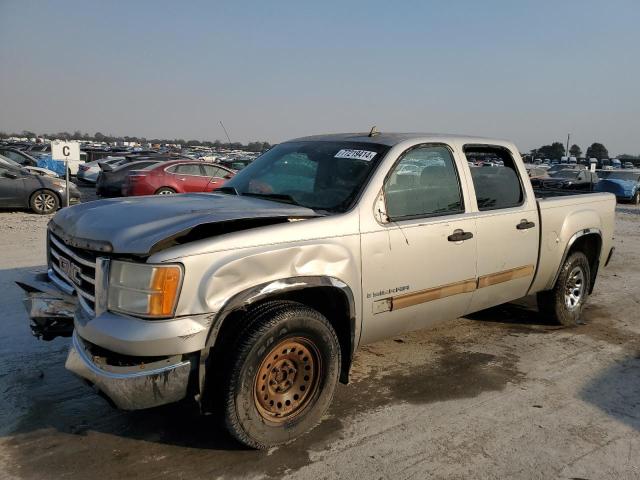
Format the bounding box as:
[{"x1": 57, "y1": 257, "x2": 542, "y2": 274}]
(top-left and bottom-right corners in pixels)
[{"x1": 16, "y1": 272, "x2": 77, "y2": 341}]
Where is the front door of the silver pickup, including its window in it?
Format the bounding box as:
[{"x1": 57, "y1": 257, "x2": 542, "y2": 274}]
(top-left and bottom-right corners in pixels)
[{"x1": 361, "y1": 144, "x2": 476, "y2": 343}]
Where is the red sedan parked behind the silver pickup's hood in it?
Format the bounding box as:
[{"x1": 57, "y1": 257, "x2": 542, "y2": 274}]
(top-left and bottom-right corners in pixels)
[{"x1": 122, "y1": 160, "x2": 235, "y2": 197}]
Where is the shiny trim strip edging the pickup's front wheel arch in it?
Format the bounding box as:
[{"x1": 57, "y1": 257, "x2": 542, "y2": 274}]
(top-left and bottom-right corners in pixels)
[{"x1": 198, "y1": 276, "x2": 361, "y2": 400}]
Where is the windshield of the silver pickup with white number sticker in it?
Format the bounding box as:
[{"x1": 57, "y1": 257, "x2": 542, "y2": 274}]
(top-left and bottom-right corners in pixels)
[{"x1": 221, "y1": 141, "x2": 389, "y2": 212}]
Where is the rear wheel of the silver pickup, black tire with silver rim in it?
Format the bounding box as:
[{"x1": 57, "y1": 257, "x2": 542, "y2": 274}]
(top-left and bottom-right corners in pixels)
[{"x1": 537, "y1": 252, "x2": 591, "y2": 327}]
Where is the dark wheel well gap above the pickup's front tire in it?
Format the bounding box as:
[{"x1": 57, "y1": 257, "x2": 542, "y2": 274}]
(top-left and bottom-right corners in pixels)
[{"x1": 213, "y1": 286, "x2": 355, "y2": 383}]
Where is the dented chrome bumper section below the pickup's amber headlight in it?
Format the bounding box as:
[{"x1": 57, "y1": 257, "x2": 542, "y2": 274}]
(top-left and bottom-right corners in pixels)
[{"x1": 65, "y1": 332, "x2": 192, "y2": 410}]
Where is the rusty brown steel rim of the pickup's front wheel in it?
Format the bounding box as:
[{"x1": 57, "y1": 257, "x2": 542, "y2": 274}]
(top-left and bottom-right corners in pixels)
[{"x1": 254, "y1": 337, "x2": 322, "y2": 423}]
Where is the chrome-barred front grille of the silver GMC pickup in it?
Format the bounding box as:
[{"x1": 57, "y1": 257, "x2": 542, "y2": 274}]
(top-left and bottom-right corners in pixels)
[{"x1": 48, "y1": 231, "x2": 97, "y2": 315}]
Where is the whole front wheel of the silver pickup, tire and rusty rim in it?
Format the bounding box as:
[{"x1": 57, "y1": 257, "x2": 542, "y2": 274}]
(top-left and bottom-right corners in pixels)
[{"x1": 220, "y1": 301, "x2": 341, "y2": 449}]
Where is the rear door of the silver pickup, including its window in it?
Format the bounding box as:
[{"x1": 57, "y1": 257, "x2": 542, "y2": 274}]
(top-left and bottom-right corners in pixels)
[{"x1": 464, "y1": 145, "x2": 540, "y2": 313}]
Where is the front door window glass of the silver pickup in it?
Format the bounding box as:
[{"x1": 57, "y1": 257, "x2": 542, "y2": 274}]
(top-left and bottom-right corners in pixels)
[{"x1": 384, "y1": 145, "x2": 464, "y2": 219}]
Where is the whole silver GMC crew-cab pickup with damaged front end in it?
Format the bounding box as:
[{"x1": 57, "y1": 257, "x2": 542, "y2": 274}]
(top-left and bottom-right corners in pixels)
[{"x1": 19, "y1": 130, "x2": 615, "y2": 448}]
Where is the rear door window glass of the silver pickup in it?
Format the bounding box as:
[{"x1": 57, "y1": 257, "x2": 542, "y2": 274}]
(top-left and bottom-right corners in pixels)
[{"x1": 465, "y1": 146, "x2": 524, "y2": 211}]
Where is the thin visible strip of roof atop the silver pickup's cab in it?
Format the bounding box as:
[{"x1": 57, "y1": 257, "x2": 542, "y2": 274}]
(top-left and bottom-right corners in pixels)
[{"x1": 288, "y1": 132, "x2": 512, "y2": 146}]
